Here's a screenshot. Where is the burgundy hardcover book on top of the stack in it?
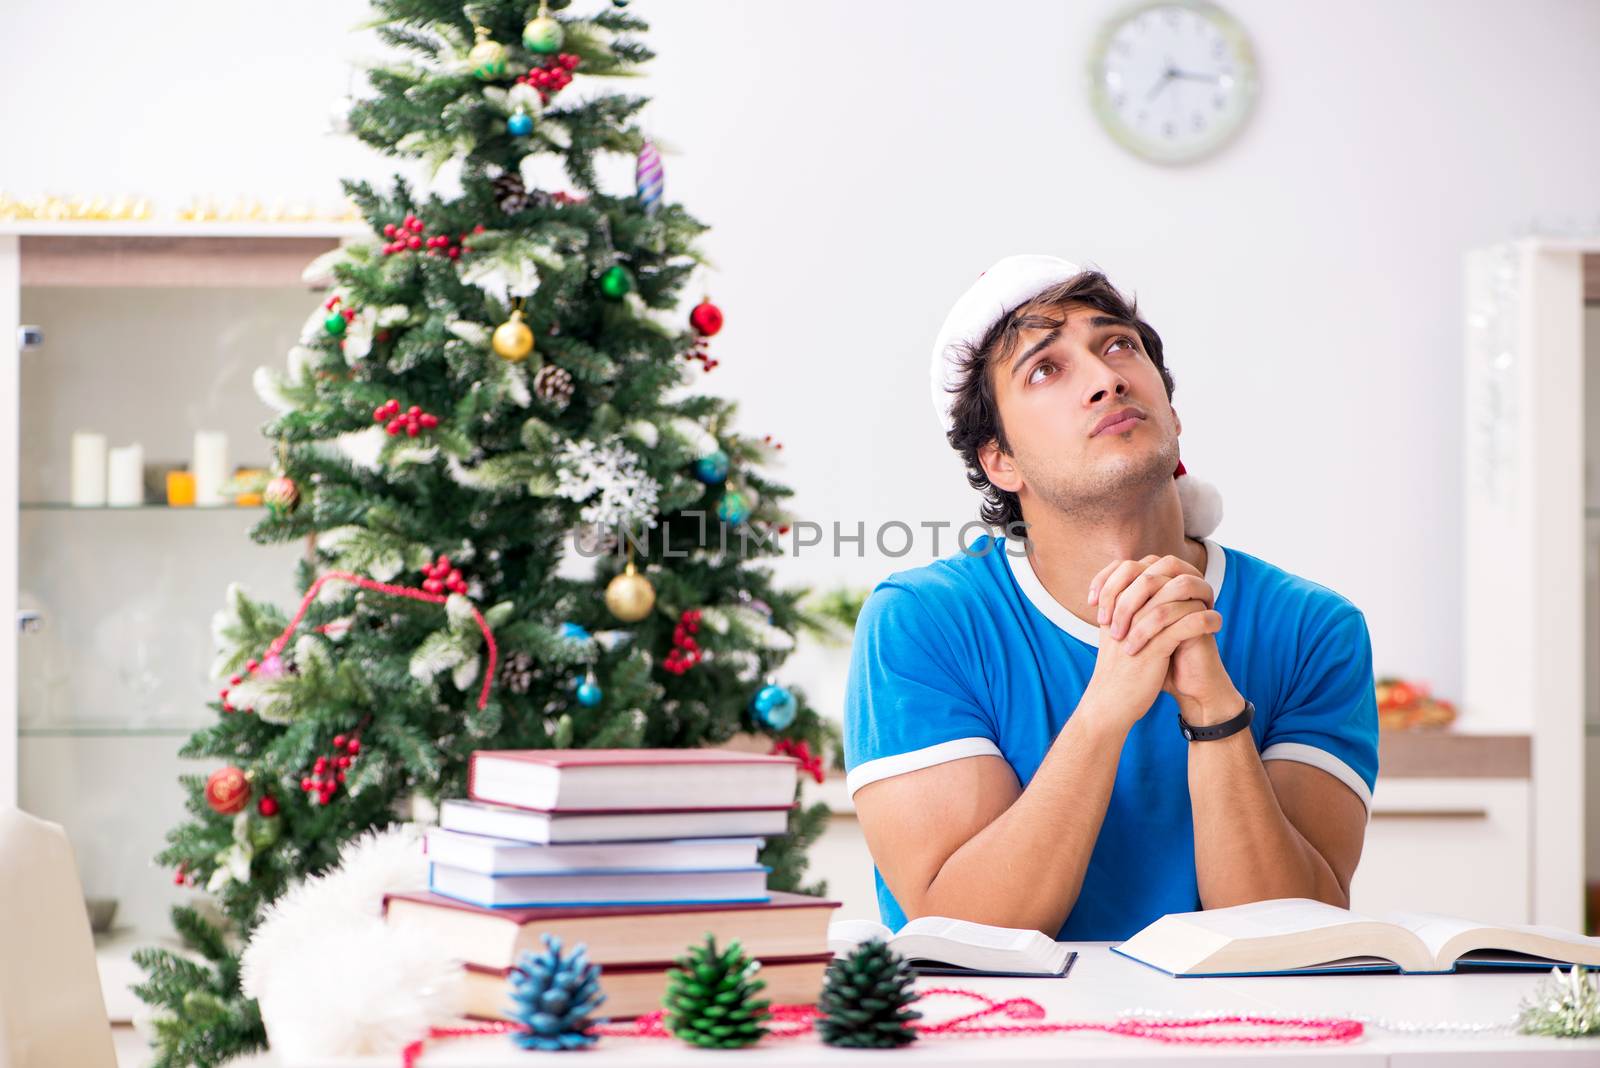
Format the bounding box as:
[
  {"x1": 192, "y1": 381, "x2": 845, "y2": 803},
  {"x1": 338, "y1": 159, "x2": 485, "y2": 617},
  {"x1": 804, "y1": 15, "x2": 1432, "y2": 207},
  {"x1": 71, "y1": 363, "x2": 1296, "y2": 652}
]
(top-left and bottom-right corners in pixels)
[{"x1": 467, "y1": 748, "x2": 800, "y2": 812}]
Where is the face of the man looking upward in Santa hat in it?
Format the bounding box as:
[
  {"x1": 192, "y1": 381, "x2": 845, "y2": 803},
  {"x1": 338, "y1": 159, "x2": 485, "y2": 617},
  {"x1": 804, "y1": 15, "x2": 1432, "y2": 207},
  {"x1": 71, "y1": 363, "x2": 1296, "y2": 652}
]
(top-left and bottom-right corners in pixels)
[{"x1": 979, "y1": 304, "x2": 1182, "y2": 518}]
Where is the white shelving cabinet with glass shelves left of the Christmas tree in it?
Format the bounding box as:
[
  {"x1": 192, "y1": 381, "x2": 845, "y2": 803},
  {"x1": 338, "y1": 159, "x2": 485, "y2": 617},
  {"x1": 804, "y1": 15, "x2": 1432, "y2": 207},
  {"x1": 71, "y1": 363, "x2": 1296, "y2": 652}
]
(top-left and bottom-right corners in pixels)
[{"x1": 0, "y1": 222, "x2": 363, "y2": 978}]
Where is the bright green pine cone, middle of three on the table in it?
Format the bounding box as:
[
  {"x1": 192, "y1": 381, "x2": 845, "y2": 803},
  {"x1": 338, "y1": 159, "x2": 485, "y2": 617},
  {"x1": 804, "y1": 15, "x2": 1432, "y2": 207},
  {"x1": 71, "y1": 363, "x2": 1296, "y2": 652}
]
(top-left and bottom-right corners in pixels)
[{"x1": 661, "y1": 935, "x2": 771, "y2": 1049}]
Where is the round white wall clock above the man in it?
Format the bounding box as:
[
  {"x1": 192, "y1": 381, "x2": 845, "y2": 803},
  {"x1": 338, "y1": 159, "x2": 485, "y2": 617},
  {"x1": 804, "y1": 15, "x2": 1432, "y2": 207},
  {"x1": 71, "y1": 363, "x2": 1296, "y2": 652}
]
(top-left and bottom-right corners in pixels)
[{"x1": 1090, "y1": 0, "x2": 1256, "y2": 163}]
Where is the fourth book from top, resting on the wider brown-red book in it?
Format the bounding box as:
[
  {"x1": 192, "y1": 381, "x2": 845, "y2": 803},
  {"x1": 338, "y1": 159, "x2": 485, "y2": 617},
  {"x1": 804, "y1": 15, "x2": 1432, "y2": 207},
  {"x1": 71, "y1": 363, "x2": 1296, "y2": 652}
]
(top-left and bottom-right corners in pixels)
[{"x1": 427, "y1": 863, "x2": 770, "y2": 908}]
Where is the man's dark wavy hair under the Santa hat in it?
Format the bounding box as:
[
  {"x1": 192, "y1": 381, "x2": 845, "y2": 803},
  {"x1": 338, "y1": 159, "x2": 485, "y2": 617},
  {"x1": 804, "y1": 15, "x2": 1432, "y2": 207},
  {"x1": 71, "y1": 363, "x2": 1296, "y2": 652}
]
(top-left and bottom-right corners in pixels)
[{"x1": 946, "y1": 270, "x2": 1174, "y2": 534}]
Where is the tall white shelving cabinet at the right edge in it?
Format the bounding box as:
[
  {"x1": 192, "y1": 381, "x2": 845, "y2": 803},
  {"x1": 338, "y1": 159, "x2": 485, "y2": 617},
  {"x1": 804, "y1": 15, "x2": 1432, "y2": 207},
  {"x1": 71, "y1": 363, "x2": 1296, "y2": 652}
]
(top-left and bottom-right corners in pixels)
[{"x1": 1459, "y1": 238, "x2": 1600, "y2": 931}]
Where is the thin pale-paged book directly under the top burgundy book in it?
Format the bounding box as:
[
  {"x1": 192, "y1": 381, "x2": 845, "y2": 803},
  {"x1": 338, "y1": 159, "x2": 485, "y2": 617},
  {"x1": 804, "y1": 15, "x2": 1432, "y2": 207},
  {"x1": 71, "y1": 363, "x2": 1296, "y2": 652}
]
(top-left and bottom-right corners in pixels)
[{"x1": 438, "y1": 801, "x2": 789, "y2": 843}]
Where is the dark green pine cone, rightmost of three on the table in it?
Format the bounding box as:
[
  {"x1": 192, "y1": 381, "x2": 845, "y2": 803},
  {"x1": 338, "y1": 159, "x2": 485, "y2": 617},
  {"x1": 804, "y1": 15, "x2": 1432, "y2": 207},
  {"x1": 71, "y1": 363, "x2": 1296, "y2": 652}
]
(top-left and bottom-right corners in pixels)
[{"x1": 816, "y1": 938, "x2": 922, "y2": 1049}]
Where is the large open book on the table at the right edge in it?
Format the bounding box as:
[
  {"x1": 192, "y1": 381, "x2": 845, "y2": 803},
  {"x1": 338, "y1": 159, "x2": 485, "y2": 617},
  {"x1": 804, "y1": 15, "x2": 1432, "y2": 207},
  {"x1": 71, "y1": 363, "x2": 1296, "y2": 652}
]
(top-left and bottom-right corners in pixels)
[{"x1": 1112, "y1": 897, "x2": 1600, "y2": 977}]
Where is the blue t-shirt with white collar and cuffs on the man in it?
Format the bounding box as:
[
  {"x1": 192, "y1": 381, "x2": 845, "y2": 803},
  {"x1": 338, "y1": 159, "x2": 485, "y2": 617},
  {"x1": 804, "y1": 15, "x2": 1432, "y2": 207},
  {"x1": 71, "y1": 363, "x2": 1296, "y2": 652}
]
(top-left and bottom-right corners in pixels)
[{"x1": 845, "y1": 536, "x2": 1378, "y2": 942}]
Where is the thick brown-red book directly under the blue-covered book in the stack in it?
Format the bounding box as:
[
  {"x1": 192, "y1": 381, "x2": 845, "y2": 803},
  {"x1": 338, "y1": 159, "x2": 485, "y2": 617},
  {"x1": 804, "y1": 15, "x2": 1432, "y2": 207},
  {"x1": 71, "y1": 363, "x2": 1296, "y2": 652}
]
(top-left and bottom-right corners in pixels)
[{"x1": 384, "y1": 891, "x2": 838, "y2": 969}]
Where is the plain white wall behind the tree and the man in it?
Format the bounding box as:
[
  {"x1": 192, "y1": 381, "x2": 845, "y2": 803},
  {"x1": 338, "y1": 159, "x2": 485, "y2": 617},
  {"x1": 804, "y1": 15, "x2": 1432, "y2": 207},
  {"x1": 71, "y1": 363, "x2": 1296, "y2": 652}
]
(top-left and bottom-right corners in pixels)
[{"x1": 0, "y1": 0, "x2": 1600, "y2": 725}]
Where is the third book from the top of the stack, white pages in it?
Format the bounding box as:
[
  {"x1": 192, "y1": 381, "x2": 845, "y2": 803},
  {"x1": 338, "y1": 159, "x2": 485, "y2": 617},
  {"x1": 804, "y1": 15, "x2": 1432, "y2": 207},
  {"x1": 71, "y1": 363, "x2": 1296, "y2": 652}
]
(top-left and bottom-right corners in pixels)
[{"x1": 427, "y1": 827, "x2": 762, "y2": 875}]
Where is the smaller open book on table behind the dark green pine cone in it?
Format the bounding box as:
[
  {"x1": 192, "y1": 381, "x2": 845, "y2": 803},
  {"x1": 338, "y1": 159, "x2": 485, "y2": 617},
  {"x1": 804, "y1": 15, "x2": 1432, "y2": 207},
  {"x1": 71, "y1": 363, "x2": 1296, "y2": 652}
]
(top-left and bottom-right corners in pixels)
[{"x1": 827, "y1": 916, "x2": 1077, "y2": 975}]
